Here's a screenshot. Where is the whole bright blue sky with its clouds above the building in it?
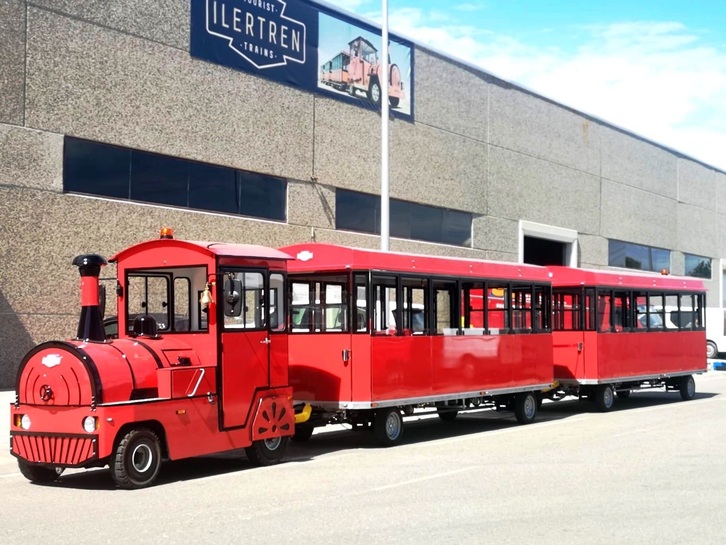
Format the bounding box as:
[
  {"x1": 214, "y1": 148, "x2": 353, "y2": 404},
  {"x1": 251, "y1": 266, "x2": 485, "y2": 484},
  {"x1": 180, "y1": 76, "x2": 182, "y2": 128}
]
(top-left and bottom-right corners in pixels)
[{"x1": 328, "y1": 0, "x2": 726, "y2": 170}]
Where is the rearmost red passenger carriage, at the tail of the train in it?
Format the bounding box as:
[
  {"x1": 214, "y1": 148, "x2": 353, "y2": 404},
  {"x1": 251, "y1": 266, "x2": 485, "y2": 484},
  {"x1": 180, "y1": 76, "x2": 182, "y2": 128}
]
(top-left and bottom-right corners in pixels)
[{"x1": 550, "y1": 267, "x2": 706, "y2": 411}]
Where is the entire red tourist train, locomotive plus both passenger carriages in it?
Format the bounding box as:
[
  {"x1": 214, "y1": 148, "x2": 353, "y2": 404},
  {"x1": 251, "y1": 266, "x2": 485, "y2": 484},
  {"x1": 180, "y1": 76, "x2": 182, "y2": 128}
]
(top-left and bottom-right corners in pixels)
[{"x1": 10, "y1": 230, "x2": 706, "y2": 488}]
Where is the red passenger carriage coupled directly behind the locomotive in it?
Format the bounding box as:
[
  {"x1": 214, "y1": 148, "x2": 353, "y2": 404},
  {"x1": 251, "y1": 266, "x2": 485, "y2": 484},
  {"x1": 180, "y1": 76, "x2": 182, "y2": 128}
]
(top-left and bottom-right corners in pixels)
[{"x1": 282, "y1": 244, "x2": 553, "y2": 444}]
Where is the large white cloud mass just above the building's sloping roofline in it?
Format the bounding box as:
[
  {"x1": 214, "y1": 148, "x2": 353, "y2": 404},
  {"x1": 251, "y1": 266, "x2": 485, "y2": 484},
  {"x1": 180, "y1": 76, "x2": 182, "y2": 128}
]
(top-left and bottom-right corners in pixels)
[{"x1": 389, "y1": 8, "x2": 726, "y2": 170}]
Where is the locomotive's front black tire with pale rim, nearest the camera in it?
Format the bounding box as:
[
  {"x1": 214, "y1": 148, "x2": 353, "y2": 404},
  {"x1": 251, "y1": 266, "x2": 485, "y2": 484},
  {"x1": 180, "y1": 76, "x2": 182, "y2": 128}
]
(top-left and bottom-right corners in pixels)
[{"x1": 111, "y1": 428, "x2": 161, "y2": 490}]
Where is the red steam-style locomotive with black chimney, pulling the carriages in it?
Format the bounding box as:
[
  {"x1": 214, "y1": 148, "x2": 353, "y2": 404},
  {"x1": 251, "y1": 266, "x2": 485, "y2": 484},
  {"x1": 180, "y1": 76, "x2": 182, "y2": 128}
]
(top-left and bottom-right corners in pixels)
[{"x1": 10, "y1": 231, "x2": 295, "y2": 488}]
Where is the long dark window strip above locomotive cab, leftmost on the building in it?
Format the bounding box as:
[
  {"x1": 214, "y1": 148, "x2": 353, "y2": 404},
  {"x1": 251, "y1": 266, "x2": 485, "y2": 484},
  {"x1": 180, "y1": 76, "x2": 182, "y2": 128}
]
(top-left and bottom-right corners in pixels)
[{"x1": 63, "y1": 137, "x2": 287, "y2": 221}]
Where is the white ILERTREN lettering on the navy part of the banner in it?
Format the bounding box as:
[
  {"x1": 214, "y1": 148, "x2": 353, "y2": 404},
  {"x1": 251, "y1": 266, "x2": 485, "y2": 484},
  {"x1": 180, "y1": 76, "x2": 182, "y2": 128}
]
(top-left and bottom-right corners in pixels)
[{"x1": 207, "y1": 1, "x2": 304, "y2": 53}]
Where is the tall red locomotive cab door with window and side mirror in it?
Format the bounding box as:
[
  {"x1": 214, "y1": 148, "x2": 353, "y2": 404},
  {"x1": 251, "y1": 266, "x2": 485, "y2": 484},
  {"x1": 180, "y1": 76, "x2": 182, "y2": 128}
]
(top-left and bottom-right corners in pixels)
[{"x1": 217, "y1": 269, "x2": 270, "y2": 429}]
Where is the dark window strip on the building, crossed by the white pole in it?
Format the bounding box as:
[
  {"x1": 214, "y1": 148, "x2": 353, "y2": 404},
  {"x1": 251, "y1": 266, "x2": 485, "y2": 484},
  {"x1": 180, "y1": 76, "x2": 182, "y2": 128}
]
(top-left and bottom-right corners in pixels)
[{"x1": 335, "y1": 189, "x2": 472, "y2": 246}]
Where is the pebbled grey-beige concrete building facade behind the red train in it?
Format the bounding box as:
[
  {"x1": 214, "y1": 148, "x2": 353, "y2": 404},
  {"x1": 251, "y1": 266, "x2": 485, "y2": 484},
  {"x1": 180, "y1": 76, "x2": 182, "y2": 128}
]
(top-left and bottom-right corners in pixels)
[{"x1": 0, "y1": 0, "x2": 726, "y2": 388}]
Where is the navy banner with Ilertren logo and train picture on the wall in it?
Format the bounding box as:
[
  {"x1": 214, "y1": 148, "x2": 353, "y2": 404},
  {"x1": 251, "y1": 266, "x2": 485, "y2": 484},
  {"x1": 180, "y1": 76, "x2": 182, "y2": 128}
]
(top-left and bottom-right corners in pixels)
[{"x1": 190, "y1": 0, "x2": 413, "y2": 120}]
